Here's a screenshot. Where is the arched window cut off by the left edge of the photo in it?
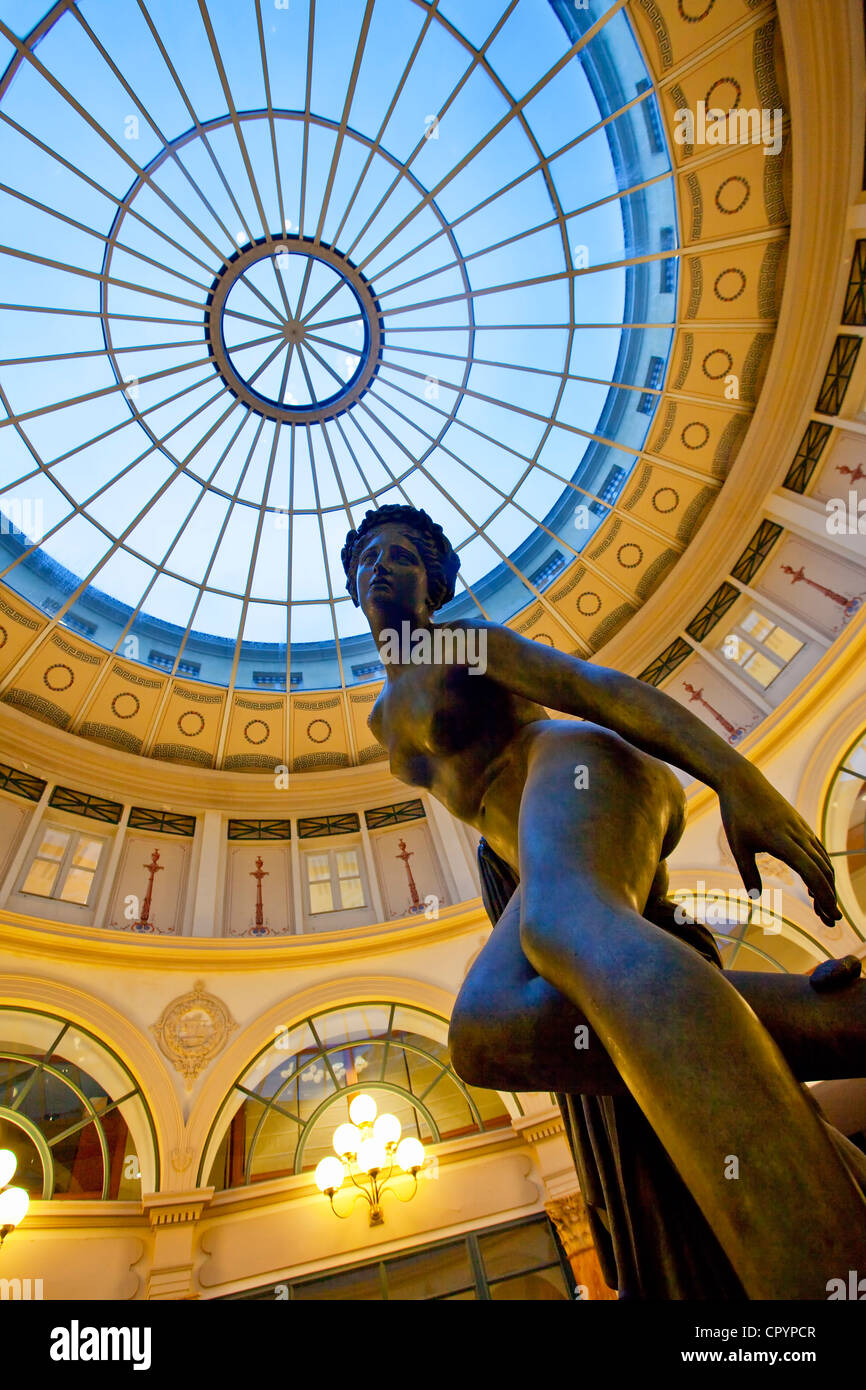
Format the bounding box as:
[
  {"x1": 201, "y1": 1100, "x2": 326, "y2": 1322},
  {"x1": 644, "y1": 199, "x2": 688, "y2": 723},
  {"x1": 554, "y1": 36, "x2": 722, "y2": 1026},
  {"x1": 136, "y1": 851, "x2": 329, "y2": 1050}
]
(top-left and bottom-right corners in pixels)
[{"x1": 0, "y1": 1009, "x2": 158, "y2": 1201}]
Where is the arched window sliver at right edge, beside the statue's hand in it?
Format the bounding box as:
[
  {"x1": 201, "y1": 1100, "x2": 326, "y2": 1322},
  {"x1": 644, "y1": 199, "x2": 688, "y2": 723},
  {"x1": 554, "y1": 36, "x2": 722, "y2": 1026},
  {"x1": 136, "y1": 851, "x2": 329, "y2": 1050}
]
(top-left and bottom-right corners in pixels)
[{"x1": 822, "y1": 734, "x2": 866, "y2": 940}]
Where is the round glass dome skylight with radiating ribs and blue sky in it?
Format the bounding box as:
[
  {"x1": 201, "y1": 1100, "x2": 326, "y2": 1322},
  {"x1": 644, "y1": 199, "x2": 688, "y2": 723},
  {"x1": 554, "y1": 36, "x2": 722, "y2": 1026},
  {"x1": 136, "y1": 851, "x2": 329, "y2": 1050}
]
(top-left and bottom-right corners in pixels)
[{"x1": 0, "y1": 0, "x2": 676, "y2": 689}]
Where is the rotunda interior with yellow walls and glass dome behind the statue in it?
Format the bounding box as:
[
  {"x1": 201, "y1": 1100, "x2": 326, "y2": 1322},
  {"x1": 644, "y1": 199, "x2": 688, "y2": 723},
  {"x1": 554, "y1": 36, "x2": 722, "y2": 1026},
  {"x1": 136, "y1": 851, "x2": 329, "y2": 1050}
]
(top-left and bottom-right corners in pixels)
[{"x1": 0, "y1": 0, "x2": 866, "y2": 1301}]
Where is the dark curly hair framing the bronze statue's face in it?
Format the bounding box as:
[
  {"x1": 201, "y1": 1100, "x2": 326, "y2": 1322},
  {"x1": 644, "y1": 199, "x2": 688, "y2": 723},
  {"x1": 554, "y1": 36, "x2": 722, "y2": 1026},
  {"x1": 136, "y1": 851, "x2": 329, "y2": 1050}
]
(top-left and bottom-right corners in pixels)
[{"x1": 341, "y1": 503, "x2": 460, "y2": 613}]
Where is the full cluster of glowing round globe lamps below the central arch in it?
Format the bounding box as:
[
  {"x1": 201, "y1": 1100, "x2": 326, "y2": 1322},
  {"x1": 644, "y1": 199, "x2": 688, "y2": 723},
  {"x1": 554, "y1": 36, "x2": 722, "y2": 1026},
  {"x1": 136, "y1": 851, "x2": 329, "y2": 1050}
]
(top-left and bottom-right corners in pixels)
[{"x1": 316, "y1": 1095, "x2": 424, "y2": 1226}]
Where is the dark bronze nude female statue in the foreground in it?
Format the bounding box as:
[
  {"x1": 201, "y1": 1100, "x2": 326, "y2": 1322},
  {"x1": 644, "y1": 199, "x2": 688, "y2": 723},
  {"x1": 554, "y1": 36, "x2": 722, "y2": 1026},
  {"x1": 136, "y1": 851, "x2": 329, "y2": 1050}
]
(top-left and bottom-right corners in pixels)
[{"x1": 342, "y1": 506, "x2": 866, "y2": 1298}]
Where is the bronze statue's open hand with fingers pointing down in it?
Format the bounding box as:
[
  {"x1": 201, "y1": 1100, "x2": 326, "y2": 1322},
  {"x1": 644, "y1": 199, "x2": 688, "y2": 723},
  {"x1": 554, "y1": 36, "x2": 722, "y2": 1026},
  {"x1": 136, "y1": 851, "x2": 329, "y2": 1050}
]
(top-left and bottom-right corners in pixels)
[{"x1": 719, "y1": 762, "x2": 842, "y2": 926}]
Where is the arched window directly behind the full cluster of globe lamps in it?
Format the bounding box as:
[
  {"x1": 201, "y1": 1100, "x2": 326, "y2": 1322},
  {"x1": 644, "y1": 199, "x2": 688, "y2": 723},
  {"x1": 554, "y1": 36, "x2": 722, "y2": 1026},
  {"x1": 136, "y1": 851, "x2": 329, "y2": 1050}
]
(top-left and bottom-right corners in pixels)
[{"x1": 203, "y1": 1004, "x2": 510, "y2": 1188}]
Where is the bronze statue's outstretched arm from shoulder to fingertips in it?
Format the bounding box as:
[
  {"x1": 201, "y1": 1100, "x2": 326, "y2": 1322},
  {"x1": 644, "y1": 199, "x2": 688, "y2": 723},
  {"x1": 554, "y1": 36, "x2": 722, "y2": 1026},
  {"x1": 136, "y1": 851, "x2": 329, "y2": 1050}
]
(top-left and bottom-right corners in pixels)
[{"x1": 473, "y1": 624, "x2": 841, "y2": 926}]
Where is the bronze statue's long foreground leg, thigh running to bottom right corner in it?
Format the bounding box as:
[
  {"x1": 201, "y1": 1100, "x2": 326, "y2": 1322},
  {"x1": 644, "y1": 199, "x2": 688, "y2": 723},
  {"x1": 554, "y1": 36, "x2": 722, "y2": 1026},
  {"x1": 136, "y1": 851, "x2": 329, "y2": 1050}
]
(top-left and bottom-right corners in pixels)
[{"x1": 520, "y1": 723, "x2": 866, "y2": 1298}]
